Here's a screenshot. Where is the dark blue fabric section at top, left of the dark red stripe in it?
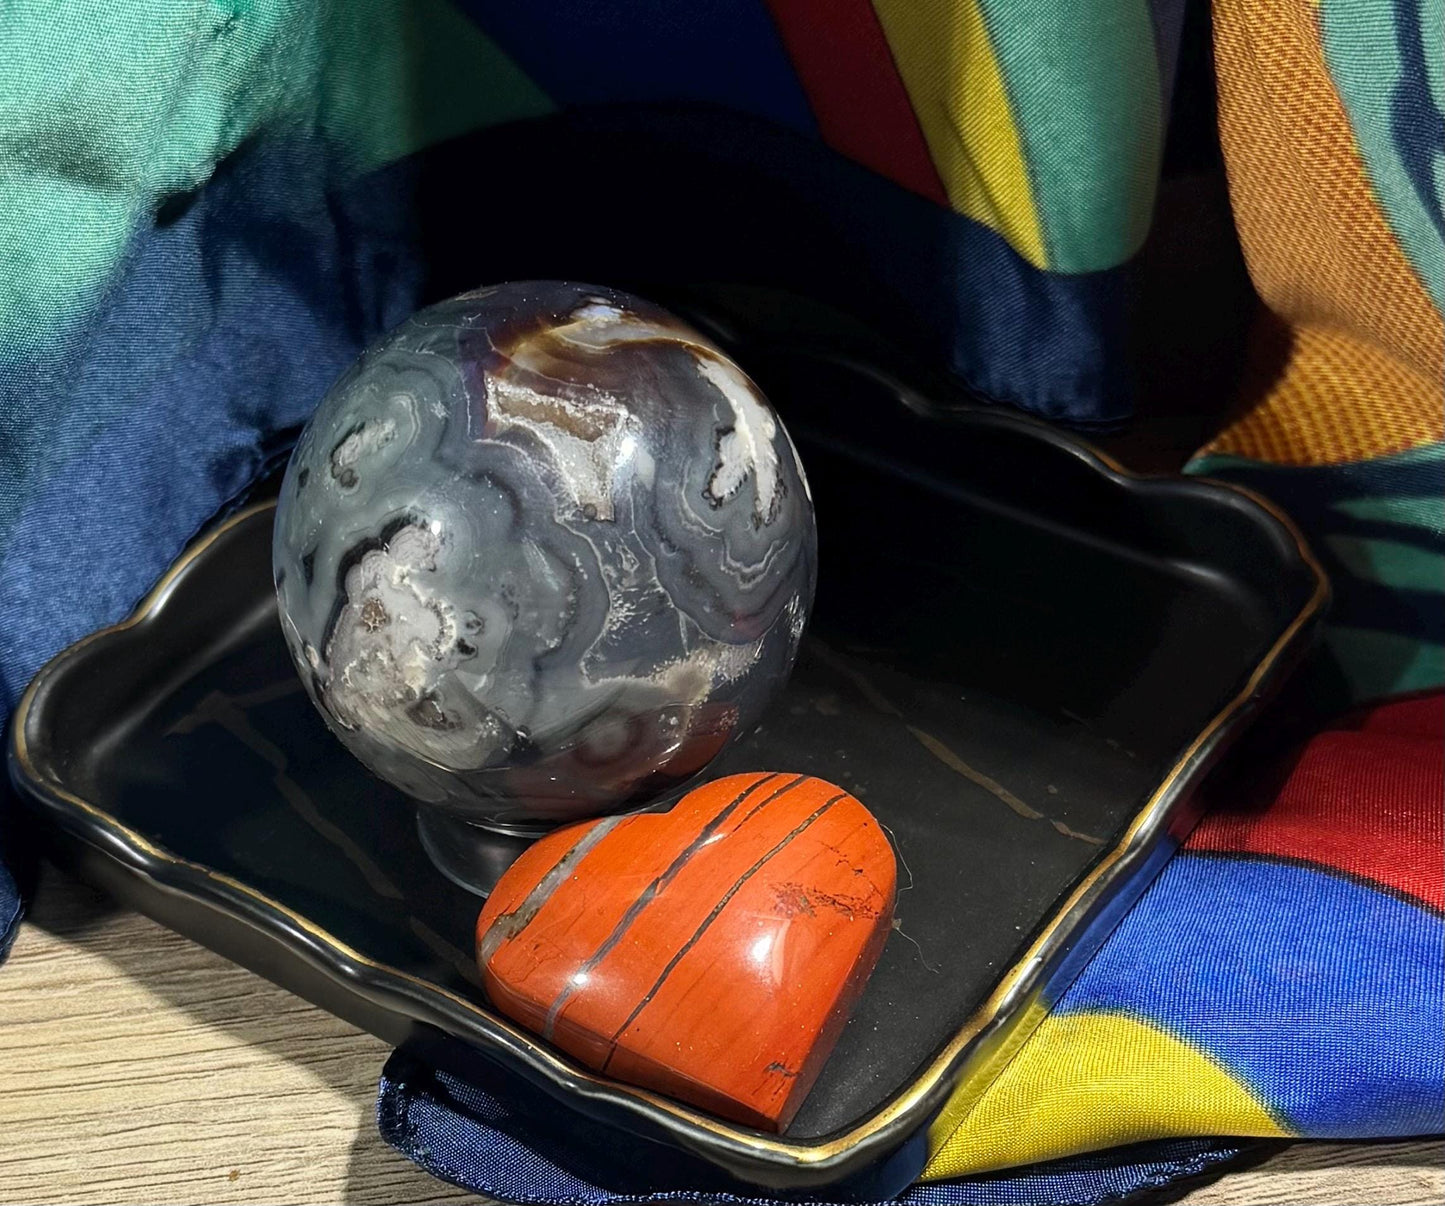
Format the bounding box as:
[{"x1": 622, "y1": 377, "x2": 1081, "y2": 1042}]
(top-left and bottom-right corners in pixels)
[{"x1": 458, "y1": 0, "x2": 816, "y2": 133}]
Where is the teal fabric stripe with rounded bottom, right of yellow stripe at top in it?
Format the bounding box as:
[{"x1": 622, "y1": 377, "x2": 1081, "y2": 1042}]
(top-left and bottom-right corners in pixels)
[{"x1": 980, "y1": 0, "x2": 1165, "y2": 273}]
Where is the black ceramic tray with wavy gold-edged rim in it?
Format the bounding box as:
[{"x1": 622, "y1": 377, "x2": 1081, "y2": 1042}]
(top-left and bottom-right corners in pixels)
[{"x1": 10, "y1": 348, "x2": 1327, "y2": 1186}]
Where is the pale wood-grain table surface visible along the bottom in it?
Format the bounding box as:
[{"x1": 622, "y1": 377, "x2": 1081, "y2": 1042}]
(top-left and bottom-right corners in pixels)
[{"x1": 0, "y1": 871, "x2": 1445, "y2": 1206}]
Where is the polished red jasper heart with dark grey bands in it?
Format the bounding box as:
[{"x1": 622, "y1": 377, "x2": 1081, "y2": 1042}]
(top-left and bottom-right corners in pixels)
[{"x1": 477, "y1": 774, "x2": 897, "y2": 1131}]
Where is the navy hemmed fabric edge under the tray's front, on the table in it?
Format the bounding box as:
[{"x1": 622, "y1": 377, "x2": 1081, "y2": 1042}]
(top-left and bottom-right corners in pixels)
[{"x1": 377, "y1": 1053, "x2": 1241, "y2": 1206}]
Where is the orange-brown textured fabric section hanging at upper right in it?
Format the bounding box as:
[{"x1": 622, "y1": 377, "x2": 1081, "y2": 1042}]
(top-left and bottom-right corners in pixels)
[{"x1": 1204, "y1": 0, "x2": 1445, "y2": 465}]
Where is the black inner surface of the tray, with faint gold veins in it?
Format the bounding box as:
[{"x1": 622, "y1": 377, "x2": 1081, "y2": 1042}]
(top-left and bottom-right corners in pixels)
[{"x1": 22, "y1": 349, "x2": 1311, "y2": 1141}]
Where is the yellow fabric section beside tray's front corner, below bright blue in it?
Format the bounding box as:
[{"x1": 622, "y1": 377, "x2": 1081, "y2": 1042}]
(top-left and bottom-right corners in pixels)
[{"x1": 923, "y1": 1014, "x2": 1289, "y2": 1180}]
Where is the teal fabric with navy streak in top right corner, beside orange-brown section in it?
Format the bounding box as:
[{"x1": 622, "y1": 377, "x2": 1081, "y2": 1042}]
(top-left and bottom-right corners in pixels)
[{"x1": 1319, "y1": 0, "x2": 1445, "y2": 313}]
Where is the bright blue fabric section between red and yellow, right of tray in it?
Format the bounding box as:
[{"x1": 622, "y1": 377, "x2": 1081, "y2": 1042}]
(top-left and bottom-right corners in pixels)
[{"x1": 1058, "y1": 854, "x2": 1445, "y2": 1138}]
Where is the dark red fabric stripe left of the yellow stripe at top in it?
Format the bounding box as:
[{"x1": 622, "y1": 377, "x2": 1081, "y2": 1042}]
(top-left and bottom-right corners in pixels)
[{"x1": 767, "y1": 0, "x2": 948, "y2": 205}]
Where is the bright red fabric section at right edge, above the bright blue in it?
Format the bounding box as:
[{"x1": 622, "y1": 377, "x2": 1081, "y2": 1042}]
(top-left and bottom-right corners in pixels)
[{"x1": 1186, "y1": 693, "x2": 1445, "y2": 908}]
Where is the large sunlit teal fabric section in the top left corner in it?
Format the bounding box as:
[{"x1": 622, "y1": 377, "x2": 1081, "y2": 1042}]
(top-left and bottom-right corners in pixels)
[{"x1": 0, "y1": 0, "x2": 551, "y2": 349}]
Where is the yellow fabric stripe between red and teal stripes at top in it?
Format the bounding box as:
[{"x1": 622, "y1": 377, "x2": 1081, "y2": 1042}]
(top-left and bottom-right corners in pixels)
[{"x1": 873, "y1": 0, "x2": 1049, "y2": 269}]
